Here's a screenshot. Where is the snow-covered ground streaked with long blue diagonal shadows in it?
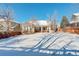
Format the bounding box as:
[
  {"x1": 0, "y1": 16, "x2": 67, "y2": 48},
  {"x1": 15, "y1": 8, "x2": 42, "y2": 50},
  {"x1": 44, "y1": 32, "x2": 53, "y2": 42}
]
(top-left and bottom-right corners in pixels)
[{"x1": 0, "y1": 32, "x2": 79, "y2": 55}]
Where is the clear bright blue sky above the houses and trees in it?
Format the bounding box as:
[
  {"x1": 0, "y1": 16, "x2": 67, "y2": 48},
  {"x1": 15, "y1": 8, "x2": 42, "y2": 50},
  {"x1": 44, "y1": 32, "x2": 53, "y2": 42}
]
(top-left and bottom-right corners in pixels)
[{"x1": 0, "y1": 3, "x2": 79, "y2": 23}]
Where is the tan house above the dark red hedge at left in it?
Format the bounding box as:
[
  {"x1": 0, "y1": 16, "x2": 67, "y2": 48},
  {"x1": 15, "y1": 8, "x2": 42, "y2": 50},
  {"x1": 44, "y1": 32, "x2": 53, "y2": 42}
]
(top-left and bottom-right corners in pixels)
[{"x1": 0, "y1": 18, "x2": 21, "y2": 32}]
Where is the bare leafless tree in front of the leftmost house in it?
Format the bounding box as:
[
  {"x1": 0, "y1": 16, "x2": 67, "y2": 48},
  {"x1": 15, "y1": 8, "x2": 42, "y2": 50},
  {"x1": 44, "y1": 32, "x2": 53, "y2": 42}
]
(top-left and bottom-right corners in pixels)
[{"x1": 0, "y1": 5, "x2": 13, "y2": 32}]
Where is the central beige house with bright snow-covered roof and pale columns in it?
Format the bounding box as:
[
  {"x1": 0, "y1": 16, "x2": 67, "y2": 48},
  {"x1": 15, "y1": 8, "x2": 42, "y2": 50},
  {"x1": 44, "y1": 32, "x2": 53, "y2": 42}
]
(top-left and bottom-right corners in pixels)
[{"x1": 22, "y1": 20, "x2": 53, "y2": 33}]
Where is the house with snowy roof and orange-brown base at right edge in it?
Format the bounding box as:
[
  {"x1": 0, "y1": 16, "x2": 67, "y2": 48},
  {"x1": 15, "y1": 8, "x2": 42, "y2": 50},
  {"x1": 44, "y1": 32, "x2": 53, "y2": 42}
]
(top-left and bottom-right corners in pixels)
[{"x1": 66, "y1": 13, "x2": 79, "y2": 34}]
